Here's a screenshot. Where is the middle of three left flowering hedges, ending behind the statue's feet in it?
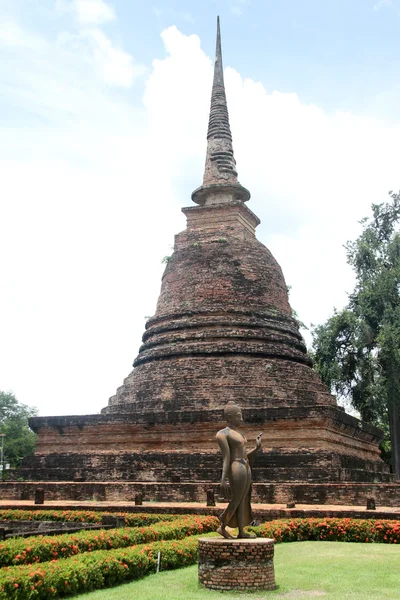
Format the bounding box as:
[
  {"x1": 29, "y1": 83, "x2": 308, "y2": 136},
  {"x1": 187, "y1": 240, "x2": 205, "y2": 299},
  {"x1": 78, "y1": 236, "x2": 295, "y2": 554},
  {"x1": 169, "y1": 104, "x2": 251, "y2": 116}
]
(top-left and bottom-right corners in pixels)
[{"x1": 0, "y1": 515, "x2": 219, "y2": 567}]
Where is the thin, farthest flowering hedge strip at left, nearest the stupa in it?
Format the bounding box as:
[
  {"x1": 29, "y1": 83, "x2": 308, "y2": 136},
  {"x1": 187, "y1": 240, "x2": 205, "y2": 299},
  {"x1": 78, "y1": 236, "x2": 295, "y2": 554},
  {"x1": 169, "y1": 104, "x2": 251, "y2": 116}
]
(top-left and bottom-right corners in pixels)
[{"x1": 0, "y1": 509, "x2": 177, "y2": 527}]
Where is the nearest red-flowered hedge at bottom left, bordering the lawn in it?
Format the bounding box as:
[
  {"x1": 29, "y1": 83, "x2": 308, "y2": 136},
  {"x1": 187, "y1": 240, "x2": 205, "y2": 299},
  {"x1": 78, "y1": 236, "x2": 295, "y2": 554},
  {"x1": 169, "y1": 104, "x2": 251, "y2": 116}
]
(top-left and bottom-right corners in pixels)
[{"x1": 0, "y1": 536, "x2": 202, "y2": 600}]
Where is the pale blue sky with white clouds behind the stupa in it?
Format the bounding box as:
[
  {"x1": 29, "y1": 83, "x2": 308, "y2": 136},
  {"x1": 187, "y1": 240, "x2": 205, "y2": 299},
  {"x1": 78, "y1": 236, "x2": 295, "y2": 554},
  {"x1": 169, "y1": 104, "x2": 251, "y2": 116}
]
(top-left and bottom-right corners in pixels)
[{"x1": 0, "y1": 0, "x2": 400, "y2": 415}]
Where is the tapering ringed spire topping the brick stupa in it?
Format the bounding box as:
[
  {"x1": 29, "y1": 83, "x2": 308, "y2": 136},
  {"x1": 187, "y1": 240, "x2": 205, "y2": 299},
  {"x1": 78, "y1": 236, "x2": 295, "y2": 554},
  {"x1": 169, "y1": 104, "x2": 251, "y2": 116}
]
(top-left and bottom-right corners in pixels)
[{"x1": 192, "y1": 17, "x2": 250, "y2": 204}]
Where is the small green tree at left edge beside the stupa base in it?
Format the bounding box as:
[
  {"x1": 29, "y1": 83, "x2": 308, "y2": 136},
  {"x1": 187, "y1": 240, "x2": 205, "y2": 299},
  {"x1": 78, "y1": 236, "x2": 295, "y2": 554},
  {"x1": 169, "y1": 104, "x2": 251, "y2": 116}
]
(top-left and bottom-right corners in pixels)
[{"x1": 0, "y1": 391, "x2": 37, "y2": 467}]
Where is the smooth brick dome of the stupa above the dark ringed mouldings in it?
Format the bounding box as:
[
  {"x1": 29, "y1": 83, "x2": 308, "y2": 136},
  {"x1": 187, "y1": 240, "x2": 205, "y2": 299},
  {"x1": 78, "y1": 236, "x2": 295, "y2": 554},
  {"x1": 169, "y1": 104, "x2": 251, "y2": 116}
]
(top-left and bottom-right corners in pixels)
[{"x1": 156, "y1": 223, "x2": 291, "y2": 317}]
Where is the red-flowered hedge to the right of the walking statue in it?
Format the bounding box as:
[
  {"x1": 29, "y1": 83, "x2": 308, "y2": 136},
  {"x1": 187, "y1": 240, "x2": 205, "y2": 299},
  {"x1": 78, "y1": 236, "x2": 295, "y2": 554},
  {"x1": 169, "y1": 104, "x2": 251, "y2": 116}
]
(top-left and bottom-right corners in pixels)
[{"x1": 251, "y1": 518, "x2": 400, "y2": 544}]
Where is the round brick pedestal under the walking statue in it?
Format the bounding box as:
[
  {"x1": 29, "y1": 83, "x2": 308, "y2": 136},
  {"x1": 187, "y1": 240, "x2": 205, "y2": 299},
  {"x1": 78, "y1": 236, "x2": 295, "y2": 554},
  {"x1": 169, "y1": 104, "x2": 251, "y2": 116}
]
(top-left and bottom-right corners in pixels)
[{"x1": 199, "y1": 537, "x2": 276, "y2": 590}]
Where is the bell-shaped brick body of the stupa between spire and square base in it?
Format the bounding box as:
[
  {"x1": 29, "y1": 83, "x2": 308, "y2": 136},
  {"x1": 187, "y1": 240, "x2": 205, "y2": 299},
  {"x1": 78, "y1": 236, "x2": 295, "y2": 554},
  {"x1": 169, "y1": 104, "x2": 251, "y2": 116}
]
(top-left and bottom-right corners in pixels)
[{"x1": 103, "y1": 203, "x2": 318, "y2": 414}]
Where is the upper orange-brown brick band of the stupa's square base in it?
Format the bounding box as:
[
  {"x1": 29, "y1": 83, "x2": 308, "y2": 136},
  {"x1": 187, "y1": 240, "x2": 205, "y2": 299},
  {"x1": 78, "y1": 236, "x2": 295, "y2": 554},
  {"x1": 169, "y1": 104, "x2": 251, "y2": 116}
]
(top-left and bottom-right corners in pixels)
[{"x1": 27, "y1": 399, "x2": 387, "y2": 464}]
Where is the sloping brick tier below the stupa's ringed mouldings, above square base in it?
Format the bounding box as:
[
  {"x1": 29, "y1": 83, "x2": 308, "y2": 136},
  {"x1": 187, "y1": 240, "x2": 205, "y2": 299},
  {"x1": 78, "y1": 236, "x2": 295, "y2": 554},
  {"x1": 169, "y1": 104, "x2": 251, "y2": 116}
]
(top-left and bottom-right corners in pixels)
[{"x1": 103, "y1": 354, "x2": 336, "y2": 420}]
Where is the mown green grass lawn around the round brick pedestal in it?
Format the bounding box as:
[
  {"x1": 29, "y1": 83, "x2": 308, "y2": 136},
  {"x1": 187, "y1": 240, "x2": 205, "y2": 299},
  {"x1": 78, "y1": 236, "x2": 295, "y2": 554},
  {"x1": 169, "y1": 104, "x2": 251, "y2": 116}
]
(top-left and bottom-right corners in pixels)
[{"x1": 77, "y1": 542, "x2": 400, "y2": 600}]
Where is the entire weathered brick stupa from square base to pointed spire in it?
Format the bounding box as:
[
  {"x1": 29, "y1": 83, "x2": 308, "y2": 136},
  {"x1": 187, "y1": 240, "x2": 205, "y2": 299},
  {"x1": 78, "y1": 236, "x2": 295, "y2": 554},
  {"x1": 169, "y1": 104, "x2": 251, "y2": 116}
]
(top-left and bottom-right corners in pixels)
[{"x1": 13, "y1": 22, "x2": 399, "y2": 505}]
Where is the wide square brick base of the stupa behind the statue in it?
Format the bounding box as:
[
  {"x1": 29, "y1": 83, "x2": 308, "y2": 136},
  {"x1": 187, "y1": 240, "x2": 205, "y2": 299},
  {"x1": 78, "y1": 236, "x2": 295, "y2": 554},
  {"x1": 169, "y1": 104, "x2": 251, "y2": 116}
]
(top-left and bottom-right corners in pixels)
[{"x1": 18, "y1": 401, "x2": 391, "y2": 485}]
